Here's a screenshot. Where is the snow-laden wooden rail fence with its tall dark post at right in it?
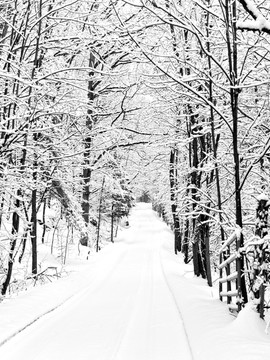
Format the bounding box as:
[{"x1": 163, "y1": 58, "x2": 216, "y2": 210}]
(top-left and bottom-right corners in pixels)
[{"x1": 218, "y1": 194, "x2": 270, "y2": 319}]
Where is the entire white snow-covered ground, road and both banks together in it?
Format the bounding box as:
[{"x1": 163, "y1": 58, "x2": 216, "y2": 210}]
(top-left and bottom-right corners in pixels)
[{"x1": 0, "y1": 204, "x2": 270, "y2": 360}]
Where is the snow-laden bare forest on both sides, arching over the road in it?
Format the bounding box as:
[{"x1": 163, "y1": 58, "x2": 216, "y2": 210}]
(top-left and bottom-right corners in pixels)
[{"x1": 0, "y1": 0, "x2": 270, "y2": 317}]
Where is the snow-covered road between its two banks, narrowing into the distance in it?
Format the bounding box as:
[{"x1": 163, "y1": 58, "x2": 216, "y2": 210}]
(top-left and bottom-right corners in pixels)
[{"x1": 0, "y1": 206, "x2": 192, "y2": 360}]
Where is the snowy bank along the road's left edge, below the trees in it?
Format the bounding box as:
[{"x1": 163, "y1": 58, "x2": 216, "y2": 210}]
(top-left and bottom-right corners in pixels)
[{"x1": 0, "y1": 236, "x2": 127, "y2": 346}]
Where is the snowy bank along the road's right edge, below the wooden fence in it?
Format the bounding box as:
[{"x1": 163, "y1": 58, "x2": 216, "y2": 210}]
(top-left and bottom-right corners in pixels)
[{"x1": 161, "y1": 229, "x2": 270, "y2": 360}]
